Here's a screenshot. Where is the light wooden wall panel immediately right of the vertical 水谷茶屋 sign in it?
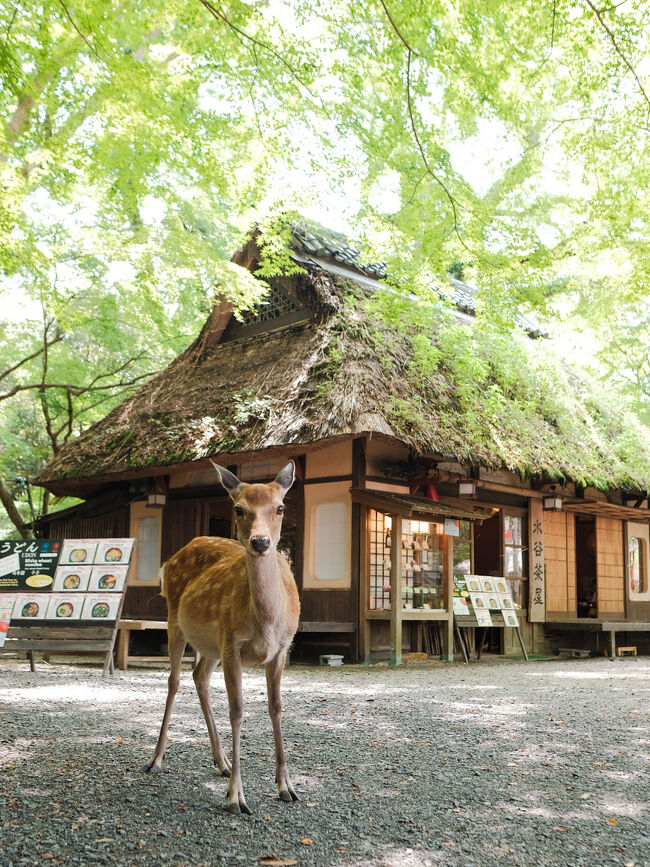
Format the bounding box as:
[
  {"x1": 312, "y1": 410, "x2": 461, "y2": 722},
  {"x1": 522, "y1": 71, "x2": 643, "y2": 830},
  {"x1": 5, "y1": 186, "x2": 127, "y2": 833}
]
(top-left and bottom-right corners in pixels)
[{"x1": 544, "y1": 512, "x2": 578, "y2": 620}]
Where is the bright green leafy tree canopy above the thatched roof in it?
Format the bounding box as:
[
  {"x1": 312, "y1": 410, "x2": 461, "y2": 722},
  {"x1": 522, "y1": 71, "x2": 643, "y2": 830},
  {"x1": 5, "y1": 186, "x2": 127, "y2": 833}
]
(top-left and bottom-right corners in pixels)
[{"x1": 0, "y1": 0, "x2": 650, "y2": 532}]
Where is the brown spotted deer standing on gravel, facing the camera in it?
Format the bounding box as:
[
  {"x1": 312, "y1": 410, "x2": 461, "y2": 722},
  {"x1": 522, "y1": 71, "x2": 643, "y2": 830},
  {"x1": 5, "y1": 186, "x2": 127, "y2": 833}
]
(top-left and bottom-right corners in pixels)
[{"x1": 142, "y1": 461, "x2": 300, "y2": 815}]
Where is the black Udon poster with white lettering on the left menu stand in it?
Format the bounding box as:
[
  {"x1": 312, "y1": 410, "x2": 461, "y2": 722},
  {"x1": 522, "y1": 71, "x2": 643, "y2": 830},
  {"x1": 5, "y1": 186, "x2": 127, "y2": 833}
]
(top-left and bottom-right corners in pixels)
[{"x1": 0, "y1": 539, "x2": 63, "y2": 593}]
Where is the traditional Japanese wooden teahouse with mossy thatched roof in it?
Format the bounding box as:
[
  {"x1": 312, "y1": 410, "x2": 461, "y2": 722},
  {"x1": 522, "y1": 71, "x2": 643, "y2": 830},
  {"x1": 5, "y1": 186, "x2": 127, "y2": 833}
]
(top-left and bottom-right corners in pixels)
[{"x1": 34, "y1": 226, "x2": 650, "y2": 661}]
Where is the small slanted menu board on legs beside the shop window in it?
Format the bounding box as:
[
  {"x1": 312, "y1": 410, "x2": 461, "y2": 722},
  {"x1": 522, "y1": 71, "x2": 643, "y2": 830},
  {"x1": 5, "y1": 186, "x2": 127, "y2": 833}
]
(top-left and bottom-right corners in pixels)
[{"x1": 453, "y1": 575, "x2": 528, "y2": 662}]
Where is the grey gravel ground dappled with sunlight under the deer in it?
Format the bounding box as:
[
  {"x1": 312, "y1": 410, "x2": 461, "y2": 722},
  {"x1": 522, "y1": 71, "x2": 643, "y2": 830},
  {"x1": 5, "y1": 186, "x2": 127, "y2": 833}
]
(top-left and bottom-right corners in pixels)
[{"x1": 0, "y1": 658, "x2": 650, "y2": 867}]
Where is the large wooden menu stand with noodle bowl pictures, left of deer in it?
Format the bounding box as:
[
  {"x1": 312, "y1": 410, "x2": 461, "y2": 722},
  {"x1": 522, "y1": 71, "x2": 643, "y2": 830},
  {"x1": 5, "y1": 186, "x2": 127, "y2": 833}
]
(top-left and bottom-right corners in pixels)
[{"x1": 0, "y1": 539, "x2": 135, "y2": 675}]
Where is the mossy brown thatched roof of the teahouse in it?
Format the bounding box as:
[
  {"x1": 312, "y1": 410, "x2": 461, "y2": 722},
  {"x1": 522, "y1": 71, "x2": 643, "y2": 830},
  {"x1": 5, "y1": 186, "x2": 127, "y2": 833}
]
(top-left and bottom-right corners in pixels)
[{"x1": 35, "y1": 234, "x2": 650, "y2": 493}]
